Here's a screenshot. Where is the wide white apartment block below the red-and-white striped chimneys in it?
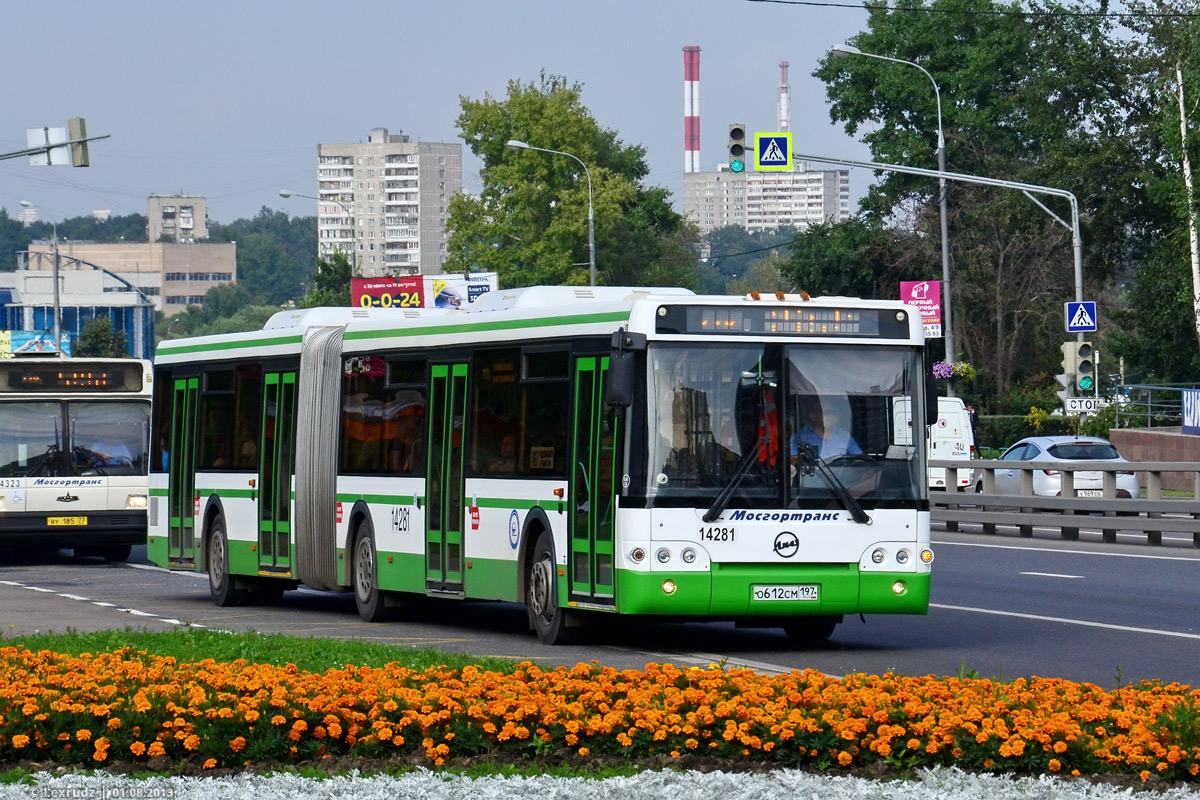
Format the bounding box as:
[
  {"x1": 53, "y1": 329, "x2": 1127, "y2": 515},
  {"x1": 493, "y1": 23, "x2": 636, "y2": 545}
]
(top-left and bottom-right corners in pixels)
[{"x1": 683, "y1": 163, "x2": 850, "y2": 234}]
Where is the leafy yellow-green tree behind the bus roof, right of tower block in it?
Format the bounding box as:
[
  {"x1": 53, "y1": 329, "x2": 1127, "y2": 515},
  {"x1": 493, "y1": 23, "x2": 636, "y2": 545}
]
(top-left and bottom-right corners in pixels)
[{"x1": 444, "y1": 72, "x2": 698, "y2": 287}]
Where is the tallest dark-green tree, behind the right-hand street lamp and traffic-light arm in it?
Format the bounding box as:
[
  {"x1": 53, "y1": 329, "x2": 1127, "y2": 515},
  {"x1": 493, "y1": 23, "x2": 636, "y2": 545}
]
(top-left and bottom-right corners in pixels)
[{"x1": 815, "y1": 0, "x2": 1141, "y2": 391}]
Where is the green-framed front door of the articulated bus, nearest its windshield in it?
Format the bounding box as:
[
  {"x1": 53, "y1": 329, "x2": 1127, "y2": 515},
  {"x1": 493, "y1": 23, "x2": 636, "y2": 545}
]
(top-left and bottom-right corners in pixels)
[{"x1": 568, "y1": 356, "x2": 619, "y2": 604}]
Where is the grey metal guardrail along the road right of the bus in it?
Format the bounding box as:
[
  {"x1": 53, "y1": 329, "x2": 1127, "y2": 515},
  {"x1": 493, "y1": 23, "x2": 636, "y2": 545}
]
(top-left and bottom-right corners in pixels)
[{"x1": 929, "y1": 459, "x2": 1200, "y2": 547}]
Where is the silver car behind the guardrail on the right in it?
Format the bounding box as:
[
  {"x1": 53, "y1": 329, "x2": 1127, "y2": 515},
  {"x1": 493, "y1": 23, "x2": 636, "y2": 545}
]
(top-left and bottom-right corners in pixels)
[{"x1": 974, "y1": 437, "x2": 1141, "y2": 498}]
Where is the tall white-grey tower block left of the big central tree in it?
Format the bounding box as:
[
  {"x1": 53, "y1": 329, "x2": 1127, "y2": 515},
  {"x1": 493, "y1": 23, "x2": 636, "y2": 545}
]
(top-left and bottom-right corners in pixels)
[{"x1": 317, "y1": 128, "x2": 462, "y2": 277}]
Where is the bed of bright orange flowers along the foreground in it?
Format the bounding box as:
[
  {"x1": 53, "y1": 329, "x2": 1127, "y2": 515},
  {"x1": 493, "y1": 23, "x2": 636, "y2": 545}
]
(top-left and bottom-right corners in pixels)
[{"x1": 0, "y1": 646, "x2": 1200, "y2": 781}]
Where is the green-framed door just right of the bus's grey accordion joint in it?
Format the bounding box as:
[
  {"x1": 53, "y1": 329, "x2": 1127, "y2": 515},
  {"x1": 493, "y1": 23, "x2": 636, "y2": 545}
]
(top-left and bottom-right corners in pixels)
[{"x1": 425, "y1": 363, "x2": 467, "y2": 594}]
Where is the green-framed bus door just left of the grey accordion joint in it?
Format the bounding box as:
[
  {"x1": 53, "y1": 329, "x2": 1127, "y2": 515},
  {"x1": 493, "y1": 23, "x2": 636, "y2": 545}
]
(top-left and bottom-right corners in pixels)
[{"x1": 258, "y1": 372, "x2": 296, "y2": 576}]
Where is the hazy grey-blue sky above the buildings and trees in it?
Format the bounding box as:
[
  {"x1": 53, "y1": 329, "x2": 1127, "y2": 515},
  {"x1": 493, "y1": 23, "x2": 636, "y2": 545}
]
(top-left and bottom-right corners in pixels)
[{"x1": 0, "y1": 0, "x2": 871, "y2": 223}]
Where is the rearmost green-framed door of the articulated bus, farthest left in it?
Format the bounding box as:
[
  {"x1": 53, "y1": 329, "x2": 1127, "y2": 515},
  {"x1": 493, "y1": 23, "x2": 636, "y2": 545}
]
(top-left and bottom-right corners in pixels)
[{"x1": 167, "y1": 378, "x2": 200, "y2": 566}]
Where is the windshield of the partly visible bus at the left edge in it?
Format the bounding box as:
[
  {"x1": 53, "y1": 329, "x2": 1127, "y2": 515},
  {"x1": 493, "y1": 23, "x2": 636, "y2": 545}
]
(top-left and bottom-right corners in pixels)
[{"x1": 0, "y1": 401, "x2": 150, "y2": 477}]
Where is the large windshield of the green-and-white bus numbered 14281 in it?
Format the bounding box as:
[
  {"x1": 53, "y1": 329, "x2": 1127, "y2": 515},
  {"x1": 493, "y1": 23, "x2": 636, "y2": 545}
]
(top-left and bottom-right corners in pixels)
[{"x1": 646, "y1": 343, "x2": 926, "y2": 509}]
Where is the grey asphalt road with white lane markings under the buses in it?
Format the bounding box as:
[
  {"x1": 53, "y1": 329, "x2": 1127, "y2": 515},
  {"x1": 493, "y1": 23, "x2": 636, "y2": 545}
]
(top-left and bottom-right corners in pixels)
[{"x1": 0, "y1": 531, "x2": 1200, "y2": 687}]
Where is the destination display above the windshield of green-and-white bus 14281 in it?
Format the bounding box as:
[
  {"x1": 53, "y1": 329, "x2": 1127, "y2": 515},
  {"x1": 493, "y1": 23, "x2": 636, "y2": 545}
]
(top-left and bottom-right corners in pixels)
[{"x1": 658, "y1": 306, "x2": 908, "y2": 338}]
